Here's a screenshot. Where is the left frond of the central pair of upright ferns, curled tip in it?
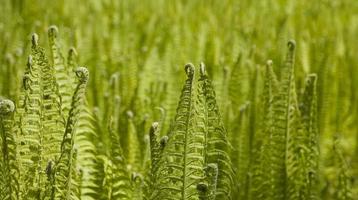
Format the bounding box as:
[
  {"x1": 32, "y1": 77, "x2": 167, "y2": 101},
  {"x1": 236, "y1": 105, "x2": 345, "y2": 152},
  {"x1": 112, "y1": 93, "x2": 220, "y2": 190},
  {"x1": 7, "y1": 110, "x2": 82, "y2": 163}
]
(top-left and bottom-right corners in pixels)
[{"x1": 151, "y1": 64, "x2": 205, "y2": 200}]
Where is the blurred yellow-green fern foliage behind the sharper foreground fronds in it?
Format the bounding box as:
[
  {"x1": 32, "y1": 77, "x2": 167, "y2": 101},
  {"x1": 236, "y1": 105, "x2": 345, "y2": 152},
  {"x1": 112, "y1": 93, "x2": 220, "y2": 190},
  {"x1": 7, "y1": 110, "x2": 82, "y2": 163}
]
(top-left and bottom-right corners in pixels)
[{"x1": 0, "y1": 0, "x2": 358, "y2": 197}]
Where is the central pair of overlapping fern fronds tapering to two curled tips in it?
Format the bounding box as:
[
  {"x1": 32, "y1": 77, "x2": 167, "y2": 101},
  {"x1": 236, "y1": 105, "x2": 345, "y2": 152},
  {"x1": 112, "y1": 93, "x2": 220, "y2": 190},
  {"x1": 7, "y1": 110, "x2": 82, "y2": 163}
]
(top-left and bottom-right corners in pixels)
[{"x1": 151, "y1": 64, "x2": 234, "y2": 200}]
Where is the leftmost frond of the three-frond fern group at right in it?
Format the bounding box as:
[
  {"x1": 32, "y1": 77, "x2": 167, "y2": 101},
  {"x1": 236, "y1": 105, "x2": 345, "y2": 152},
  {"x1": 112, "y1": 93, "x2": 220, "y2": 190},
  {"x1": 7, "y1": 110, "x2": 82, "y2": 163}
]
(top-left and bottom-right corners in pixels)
[{"x1": 250, "y1": 60, "x2": 279, "y2": 199}]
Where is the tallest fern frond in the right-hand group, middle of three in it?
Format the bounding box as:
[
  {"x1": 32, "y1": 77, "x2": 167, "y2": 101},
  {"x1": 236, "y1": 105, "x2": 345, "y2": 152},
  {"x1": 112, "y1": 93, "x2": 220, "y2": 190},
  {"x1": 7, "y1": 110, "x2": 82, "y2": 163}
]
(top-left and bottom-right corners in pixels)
[{"x1": 267, "y1": 41, "x2": 297, "y2": 200}]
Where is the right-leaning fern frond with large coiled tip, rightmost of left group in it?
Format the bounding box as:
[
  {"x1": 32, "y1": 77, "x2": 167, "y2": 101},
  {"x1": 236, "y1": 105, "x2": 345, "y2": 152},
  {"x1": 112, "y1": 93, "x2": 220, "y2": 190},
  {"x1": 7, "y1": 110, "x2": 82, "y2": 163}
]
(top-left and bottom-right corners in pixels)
[{"x1": 55, "y1": 67, "x2": 89, "y2": 200}]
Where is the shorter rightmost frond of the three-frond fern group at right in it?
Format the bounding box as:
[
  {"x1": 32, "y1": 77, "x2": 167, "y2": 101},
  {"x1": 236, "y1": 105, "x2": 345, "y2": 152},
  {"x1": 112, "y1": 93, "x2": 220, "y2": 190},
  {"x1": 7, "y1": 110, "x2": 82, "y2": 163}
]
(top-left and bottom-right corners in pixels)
[{"x1": 287, "y1": 75, "x2": 318, "y2": 200}]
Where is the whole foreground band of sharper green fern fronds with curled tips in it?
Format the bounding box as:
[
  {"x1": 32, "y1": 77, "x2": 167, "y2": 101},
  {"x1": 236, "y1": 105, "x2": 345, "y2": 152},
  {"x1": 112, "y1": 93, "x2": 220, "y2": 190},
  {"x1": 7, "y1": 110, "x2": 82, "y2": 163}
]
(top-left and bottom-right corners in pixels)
[{"x1": 0, "y1": 26, "x2": 353, "y2": 200}]
